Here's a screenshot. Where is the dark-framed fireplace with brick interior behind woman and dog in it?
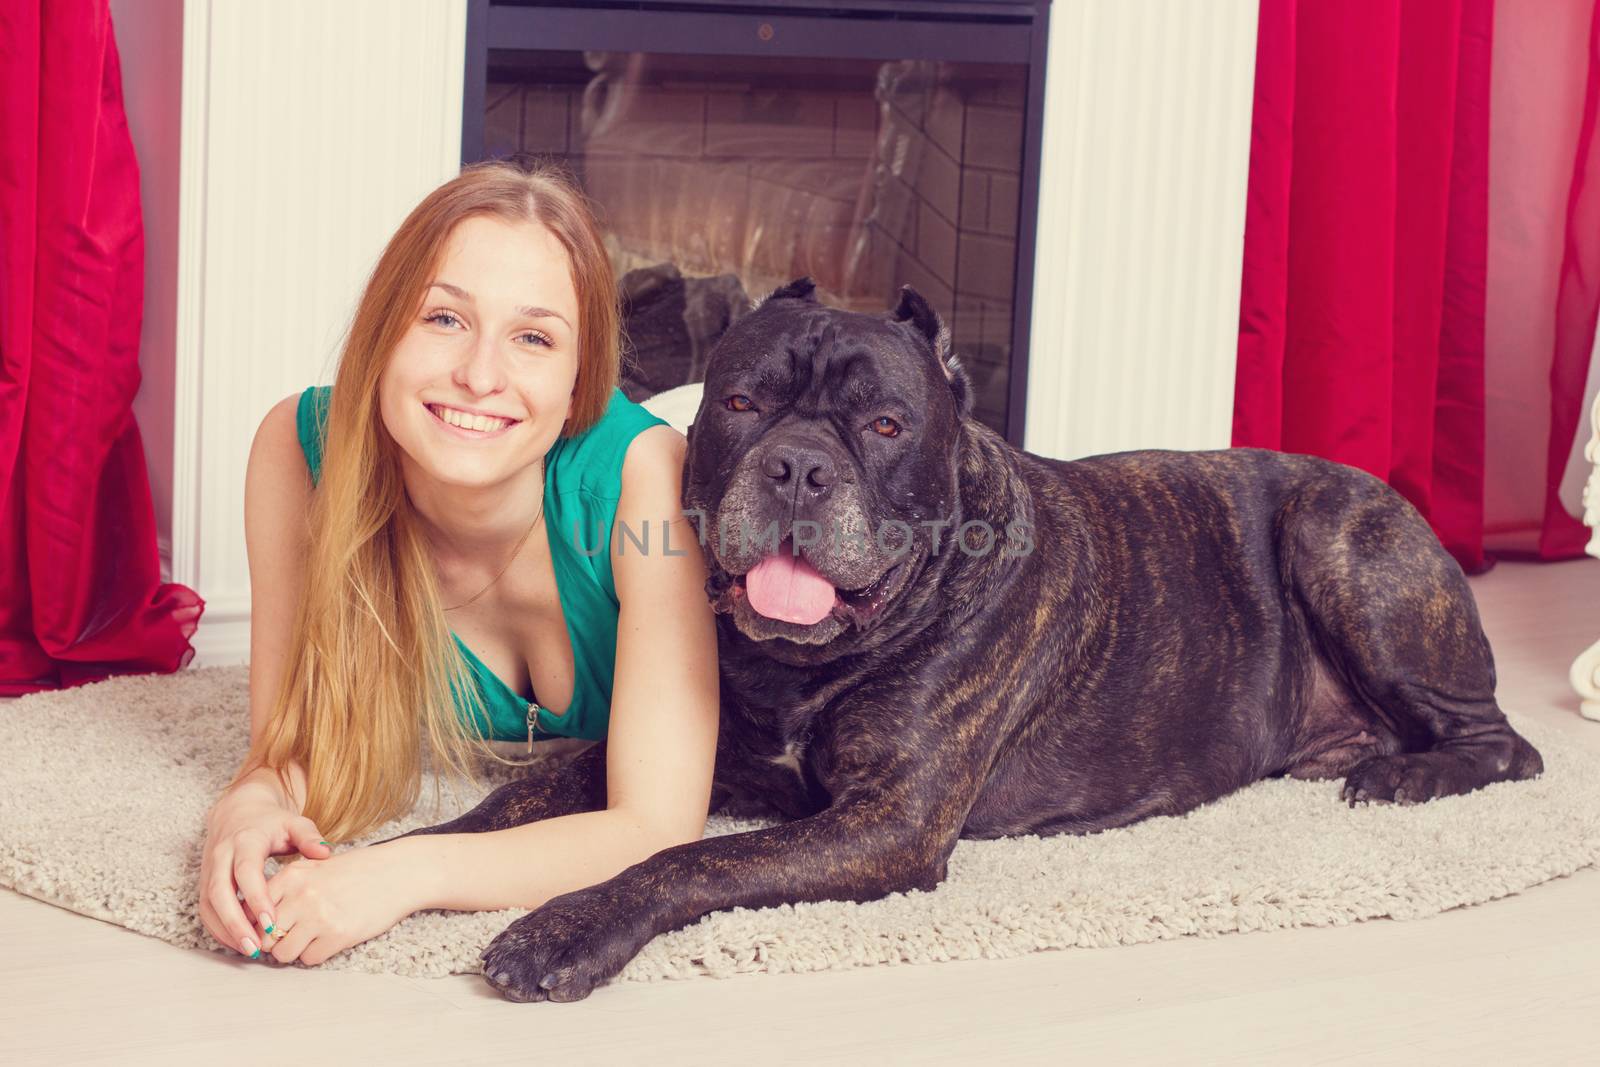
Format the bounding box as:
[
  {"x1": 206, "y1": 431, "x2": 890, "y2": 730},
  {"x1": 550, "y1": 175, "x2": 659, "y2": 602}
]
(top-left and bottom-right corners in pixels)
[{"x1": 462, "y1": 0, "x2": 1048, "y2": 445}]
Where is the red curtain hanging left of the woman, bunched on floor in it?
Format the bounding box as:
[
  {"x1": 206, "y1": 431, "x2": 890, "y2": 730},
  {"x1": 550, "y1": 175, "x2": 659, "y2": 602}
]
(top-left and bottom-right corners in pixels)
[{"x1": 0, "y1": 0, "x2": 205, "y2": 696}]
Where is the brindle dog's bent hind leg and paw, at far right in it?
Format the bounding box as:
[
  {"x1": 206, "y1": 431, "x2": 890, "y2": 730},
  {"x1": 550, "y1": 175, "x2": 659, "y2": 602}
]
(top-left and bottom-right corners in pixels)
[{"x1": 1283, "y1": 475, "x2": 1544, "y2": 805}]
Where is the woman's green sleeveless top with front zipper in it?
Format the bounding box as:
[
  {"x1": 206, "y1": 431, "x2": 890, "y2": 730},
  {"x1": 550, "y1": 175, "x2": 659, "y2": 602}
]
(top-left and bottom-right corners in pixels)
[{"x1": 296, "y1": 386, "x2": 667, "y2": 741}]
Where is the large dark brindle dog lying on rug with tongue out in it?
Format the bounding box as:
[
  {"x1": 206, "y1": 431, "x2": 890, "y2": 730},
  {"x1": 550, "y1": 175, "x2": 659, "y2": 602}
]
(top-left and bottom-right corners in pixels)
[{"x1": 380, "y1": 278, "x2": 1542, "y2": 1000}]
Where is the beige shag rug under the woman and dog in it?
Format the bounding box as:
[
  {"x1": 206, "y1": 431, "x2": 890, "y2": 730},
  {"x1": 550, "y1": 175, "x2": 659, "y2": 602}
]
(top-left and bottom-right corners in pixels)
[{"x1": 0, "y1": 667, "x2": 1600, "y2": 981}]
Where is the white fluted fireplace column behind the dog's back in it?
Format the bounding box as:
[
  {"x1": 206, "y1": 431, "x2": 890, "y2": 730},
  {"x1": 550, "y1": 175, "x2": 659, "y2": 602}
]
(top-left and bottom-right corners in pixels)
[{"x1": 1024, "y1": 0, "x2": 1258, "y2": 459}]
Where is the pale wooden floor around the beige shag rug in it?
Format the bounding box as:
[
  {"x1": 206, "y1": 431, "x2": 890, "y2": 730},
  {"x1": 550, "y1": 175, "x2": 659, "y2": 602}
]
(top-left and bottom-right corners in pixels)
[{"x1": 0, "y1": 560, "x2": 1600, "y2": 1065}]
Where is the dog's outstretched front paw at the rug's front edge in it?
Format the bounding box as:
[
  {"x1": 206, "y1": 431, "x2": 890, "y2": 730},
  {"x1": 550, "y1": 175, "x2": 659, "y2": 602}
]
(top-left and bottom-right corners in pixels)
[{"x1": 480, "y1": 886, "x2": 656, "y2": 1003}]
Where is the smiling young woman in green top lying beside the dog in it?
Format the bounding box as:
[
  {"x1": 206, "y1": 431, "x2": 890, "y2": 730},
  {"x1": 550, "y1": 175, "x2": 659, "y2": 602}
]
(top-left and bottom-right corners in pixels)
[{"x1": 200, "y1": 163, "x2": 718, "y2": 965}]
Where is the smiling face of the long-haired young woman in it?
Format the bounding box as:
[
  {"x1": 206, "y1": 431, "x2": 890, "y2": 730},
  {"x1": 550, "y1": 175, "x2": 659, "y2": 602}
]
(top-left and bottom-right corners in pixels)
[{"x1": 378, "y1": 216, "x2": 578, "y2": 486}]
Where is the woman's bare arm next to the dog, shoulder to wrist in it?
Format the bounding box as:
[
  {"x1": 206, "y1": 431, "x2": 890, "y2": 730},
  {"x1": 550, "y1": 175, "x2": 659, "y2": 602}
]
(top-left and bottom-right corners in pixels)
[{"x1": 396, "y1": 426, "x2": 720, "y2": 912}]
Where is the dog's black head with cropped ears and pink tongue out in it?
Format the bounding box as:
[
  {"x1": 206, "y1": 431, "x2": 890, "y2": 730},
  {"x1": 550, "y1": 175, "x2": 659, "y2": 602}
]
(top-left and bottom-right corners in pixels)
[{"x1": 683, "y1": 278, "x2": 973, "y2": 662}]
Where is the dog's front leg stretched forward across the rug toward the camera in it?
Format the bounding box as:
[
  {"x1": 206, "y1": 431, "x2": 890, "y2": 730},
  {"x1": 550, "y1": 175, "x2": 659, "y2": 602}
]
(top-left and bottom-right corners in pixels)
[{"x1": 482, "y1": 774, "x2": 960, "y2": 1001}]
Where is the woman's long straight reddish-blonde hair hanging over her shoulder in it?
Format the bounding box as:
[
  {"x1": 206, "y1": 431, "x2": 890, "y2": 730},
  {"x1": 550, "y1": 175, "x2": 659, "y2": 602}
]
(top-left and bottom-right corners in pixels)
[{"x1": 229, "y1": 162, "x2": 619, "y2": 841}]
